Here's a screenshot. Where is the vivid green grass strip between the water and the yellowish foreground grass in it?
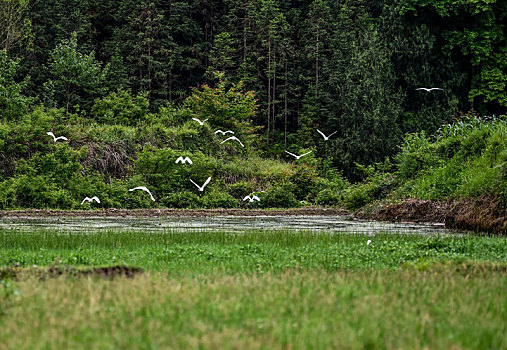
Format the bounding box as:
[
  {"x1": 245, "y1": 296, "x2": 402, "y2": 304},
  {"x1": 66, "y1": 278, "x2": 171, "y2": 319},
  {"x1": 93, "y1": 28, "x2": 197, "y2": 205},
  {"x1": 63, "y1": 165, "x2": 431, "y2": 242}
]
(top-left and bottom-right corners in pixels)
[{"x1": 0, "y1": 230, "x2": 507, "y2": 274}]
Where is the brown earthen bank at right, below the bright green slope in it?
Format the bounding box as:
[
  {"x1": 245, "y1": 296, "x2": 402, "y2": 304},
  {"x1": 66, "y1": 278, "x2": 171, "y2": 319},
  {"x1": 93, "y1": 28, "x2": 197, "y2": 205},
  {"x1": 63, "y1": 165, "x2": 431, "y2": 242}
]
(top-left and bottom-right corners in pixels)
[{"x1": 360, "y1": 196, "x2": 507, "y2": 235}]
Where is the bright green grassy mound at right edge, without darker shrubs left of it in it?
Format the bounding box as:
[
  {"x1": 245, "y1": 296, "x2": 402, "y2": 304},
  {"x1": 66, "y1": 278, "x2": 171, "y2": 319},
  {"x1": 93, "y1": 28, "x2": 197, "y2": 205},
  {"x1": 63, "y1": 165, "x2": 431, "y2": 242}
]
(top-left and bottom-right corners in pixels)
[{"x1": 395, "y1": 115, "x2": 507, "y2": 200}]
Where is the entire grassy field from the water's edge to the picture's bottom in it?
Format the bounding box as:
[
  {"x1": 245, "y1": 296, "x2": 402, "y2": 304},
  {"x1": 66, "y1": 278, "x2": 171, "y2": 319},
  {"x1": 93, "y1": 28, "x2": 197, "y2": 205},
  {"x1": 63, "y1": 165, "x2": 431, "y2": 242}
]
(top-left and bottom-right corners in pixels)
[{"x1": 0, "y1": 229, "x2": 507, "y2": 349}]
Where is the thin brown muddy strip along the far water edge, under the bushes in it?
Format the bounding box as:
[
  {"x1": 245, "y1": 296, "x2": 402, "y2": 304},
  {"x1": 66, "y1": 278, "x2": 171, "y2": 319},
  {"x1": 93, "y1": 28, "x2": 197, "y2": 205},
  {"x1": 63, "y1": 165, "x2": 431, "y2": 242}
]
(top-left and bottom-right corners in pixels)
[{"x1": 0, "y1": 208, "x2": 351, "y2": 218}]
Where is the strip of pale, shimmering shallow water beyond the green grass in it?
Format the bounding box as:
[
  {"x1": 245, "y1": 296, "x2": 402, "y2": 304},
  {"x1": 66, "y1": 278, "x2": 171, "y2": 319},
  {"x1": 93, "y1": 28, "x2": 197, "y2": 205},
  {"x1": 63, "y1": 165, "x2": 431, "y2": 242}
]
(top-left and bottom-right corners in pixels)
[{"x1": 0, "y1": 216, "x2": 450, "y2": 234}]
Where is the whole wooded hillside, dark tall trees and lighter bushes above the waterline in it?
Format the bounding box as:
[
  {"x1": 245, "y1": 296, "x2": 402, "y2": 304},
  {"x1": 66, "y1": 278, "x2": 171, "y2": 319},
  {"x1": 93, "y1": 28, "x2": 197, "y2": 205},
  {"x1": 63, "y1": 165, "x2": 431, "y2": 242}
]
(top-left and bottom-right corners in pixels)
[{"x1": 0, "y1": 0, "x2": 507, "y2": 210}]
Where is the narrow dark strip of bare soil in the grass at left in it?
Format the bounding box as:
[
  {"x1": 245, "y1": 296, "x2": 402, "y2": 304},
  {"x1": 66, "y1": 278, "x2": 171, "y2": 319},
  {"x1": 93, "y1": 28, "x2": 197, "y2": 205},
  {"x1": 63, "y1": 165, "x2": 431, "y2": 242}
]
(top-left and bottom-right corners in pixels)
[{"x1": 0, "y1": 265, "x2": 144, "y2": 279}]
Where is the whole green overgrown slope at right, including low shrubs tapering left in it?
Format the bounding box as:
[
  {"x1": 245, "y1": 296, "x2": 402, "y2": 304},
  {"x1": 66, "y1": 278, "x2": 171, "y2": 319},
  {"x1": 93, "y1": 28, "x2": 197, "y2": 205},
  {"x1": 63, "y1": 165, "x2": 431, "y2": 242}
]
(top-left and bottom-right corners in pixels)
[{"x1": 344, "y1": 114, "x2": 507, "y2": 209}]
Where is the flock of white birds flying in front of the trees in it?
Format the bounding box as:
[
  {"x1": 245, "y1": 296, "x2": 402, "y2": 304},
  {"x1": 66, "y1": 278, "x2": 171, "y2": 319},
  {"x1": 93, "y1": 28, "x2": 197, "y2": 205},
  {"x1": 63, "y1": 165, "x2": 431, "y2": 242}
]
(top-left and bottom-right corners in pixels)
[{"x1": 47, "y1": 88, "x2": 443, "y2": 211}]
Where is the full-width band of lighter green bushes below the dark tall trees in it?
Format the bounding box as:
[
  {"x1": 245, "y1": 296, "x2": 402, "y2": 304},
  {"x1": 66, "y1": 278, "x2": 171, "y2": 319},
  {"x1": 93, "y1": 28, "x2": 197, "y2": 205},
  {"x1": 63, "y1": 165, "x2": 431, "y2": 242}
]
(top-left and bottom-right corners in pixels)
[{"x1": 0, "y1": 76, "x2": 507, "y2": 210}]
